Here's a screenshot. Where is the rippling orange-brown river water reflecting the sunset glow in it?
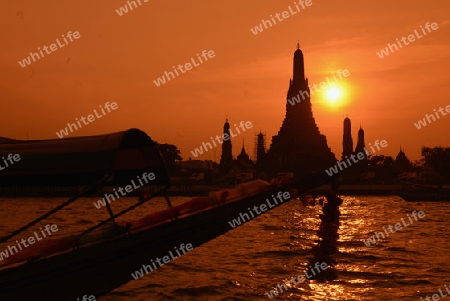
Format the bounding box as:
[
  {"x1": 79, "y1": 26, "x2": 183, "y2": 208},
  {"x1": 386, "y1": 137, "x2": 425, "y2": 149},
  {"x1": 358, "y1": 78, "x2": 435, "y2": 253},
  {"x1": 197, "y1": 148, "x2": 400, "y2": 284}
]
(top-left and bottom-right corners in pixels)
[{"x1": 0, "y1": 196, "x2": 450, "y2": 301}]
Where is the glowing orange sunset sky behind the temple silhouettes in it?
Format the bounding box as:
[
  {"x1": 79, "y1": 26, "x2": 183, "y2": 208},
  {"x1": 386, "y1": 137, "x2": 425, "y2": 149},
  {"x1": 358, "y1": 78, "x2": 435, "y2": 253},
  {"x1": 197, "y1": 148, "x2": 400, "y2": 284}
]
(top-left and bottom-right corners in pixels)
[{"x1": 0, "y1": 0, "x2": 450, "y2": 161}]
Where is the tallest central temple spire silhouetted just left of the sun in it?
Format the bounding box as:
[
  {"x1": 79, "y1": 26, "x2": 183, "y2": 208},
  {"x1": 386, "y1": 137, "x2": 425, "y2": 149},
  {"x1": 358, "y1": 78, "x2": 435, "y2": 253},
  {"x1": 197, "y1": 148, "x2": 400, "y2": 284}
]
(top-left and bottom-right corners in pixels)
[{"x1": 267, "y1": 44, "x2": 336, "y2": 177}]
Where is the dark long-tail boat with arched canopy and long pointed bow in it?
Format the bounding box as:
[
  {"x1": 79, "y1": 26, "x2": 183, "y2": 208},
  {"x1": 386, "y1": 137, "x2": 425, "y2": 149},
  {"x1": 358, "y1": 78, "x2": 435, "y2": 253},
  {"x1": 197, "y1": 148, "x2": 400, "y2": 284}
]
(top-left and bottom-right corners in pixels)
[{"x1": 0, "y1": 129, "x2": 333, "y2": 301}]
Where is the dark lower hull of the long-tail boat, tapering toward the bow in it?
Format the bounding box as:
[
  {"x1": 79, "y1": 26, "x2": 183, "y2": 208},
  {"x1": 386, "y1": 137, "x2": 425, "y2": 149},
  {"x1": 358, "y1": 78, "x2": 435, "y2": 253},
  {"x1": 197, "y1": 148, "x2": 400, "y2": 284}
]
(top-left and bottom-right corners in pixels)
[{"x1": 0, "y1": 189, "x2": 287, "y2": 301}]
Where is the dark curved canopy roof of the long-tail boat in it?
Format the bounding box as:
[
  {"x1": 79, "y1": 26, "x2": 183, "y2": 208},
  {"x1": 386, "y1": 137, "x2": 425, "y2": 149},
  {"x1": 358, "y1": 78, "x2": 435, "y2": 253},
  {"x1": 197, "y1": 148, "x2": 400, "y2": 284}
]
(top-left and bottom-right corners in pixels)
[{"x1": 0, "y1": 129, "x2": 170, "y2": 187}]
